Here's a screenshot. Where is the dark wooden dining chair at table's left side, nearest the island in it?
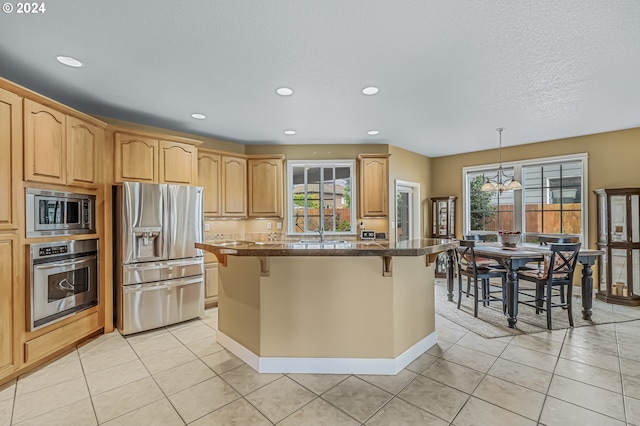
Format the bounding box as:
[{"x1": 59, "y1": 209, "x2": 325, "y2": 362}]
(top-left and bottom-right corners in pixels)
[{"x1": 455, "y1": 240, "x2": 507, "y2": 317}]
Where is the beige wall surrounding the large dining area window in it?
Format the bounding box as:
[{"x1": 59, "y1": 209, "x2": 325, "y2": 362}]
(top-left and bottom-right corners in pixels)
[{"x1": 431, "y1": 128, "x2": 640, "y2": 247}]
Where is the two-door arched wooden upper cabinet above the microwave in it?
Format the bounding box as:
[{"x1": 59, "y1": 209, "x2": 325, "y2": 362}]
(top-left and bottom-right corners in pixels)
[{"x1": 24, "y1": 99, "x2": 104, "y2": 188}]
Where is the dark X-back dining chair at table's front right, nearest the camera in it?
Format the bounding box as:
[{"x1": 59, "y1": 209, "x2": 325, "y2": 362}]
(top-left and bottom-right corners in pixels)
[{"x1": 518, "y1": 243, "x2": 580, "y2": 329}]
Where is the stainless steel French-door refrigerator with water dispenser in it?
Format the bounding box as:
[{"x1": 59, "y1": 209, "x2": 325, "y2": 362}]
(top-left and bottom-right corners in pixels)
[{"x1": 114, "y1": 182, "x2": 204, "y2": 334}]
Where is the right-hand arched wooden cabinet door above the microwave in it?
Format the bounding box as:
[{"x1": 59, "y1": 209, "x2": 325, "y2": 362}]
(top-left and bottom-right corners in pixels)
[{"x1": 67, "y1": 116, "x2": 104, "y2": 188}]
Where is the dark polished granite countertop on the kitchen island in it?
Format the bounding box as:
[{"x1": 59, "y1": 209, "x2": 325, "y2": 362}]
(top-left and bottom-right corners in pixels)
[{"x1": 196, "y1": 238, "x2": 458, "y2": 256}]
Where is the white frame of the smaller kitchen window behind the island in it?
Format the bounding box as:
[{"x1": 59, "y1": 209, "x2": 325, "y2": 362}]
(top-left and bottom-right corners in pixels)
[{"x1": 286, "y1": 159, "x2": 358, "y2": 236}]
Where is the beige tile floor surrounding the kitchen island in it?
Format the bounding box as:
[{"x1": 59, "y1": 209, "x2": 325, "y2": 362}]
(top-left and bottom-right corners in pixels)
[{"x1": 0, "y1": 296, "x2": 640, "y2": 426}]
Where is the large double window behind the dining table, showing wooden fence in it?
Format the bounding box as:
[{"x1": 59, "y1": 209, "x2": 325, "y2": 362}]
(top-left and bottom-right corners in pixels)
[{"x1": 463, "y1": 154, "x2": 587, "y2": 243}]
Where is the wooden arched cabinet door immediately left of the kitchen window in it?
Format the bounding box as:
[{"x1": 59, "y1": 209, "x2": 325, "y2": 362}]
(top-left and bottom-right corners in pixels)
[{"x1": 248, "y1": 159, "x2": 282, "y2": 217}]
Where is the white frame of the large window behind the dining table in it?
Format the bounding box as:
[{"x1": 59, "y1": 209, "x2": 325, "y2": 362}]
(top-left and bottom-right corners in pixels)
[{"x1": 462, "y1": 153, "x2": 589, "y2": 244}]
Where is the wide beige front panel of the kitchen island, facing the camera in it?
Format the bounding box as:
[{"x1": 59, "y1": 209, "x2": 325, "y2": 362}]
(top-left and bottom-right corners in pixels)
[{"x1": 260, "y1": 256, "x2": 395, "y2": 359}]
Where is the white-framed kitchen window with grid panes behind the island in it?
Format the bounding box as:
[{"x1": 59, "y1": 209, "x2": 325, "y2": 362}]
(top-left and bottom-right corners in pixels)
[{"x1": 287, "y1": 160, "x2": 357, "y2": 234}]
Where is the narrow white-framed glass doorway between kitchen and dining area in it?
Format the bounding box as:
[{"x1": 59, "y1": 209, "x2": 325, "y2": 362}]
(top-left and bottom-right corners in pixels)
[{"x1": 395, "y1": 180, "x2": 421, "y2": 242}]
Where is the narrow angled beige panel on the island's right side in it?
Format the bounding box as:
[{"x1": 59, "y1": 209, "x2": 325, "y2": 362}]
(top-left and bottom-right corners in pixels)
[{"x1": 392, "y1": 256, "x2": 436, "y2": 356}]
